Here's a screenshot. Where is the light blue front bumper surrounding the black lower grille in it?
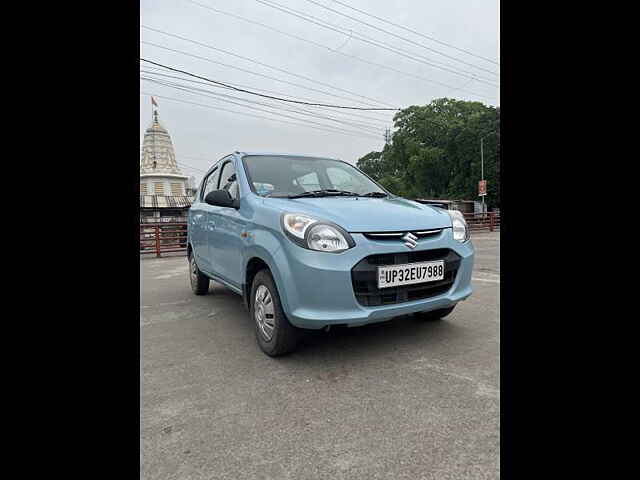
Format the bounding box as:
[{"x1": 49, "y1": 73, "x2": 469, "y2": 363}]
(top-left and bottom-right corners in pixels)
[{"x1": 276, "y1": 228, "x2": 474, "y2": 329}]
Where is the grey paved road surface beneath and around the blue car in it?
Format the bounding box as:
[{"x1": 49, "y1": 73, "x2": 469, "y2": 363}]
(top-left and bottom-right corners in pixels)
[{"x1": 140, "y1": 233, "x2": 500, "y2": 480}]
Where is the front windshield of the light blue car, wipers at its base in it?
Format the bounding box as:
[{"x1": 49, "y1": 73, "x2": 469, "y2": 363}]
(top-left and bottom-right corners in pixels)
[{"x1": 243, "y1": 155, "x2": 387, "y2": 197}]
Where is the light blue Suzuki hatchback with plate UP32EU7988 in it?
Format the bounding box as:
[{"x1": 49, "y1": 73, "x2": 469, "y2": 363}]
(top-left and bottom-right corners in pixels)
[{"x1": 187, "y1": 152, "x2": 474, "y2": 356}]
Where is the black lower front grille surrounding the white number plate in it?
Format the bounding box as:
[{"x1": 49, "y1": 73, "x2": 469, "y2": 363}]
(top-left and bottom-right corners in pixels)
[{"x1": 351, "y1": 248, "x2": 460, "y2": 307}]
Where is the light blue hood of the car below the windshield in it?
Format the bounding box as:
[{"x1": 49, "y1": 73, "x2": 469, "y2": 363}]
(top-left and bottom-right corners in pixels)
[{"x1": 265, "y1": 197, "x2": 451, "y2": 232}]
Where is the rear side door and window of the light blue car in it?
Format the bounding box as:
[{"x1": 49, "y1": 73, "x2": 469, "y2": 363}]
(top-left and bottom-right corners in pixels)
[{"x1": 190, "y1": 166, "x2": 220, "y2": 272}]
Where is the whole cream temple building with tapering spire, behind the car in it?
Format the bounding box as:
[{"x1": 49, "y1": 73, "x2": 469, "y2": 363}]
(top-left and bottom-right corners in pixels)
[{"x1": 140, "y1": 110, "x2": 193, "y2": 223}]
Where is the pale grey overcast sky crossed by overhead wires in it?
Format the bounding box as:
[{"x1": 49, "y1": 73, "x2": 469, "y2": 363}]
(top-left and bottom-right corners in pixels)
[{"x1": 140, "y1": 0, "x2": 500, "y2": 184}]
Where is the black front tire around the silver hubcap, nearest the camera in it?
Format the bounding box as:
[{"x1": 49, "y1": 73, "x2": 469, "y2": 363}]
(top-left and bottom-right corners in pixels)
[{"x1": 249, "y1": 269, "x2": 299, "y2": 357}]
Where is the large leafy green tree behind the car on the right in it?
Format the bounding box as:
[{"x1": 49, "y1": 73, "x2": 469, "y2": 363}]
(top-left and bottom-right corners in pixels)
[{"x1": 357, "y1": 98, "x2": 500, "y2": 207}]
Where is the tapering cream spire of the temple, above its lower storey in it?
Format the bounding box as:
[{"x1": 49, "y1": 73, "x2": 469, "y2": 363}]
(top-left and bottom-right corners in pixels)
[{"x1": 140, "y1": 110, "x2": 182, "y2": 175}]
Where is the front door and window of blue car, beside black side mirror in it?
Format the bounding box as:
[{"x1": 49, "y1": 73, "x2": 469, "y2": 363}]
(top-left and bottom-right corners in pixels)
[{"x1": 209, "y1": 158, "x2": 246, "y2": 288}]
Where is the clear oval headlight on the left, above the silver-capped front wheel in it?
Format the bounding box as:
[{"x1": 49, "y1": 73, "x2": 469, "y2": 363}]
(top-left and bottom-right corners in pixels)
[{"x1": 282, "y1": 213, "x2": 355, "y2": 253}]
